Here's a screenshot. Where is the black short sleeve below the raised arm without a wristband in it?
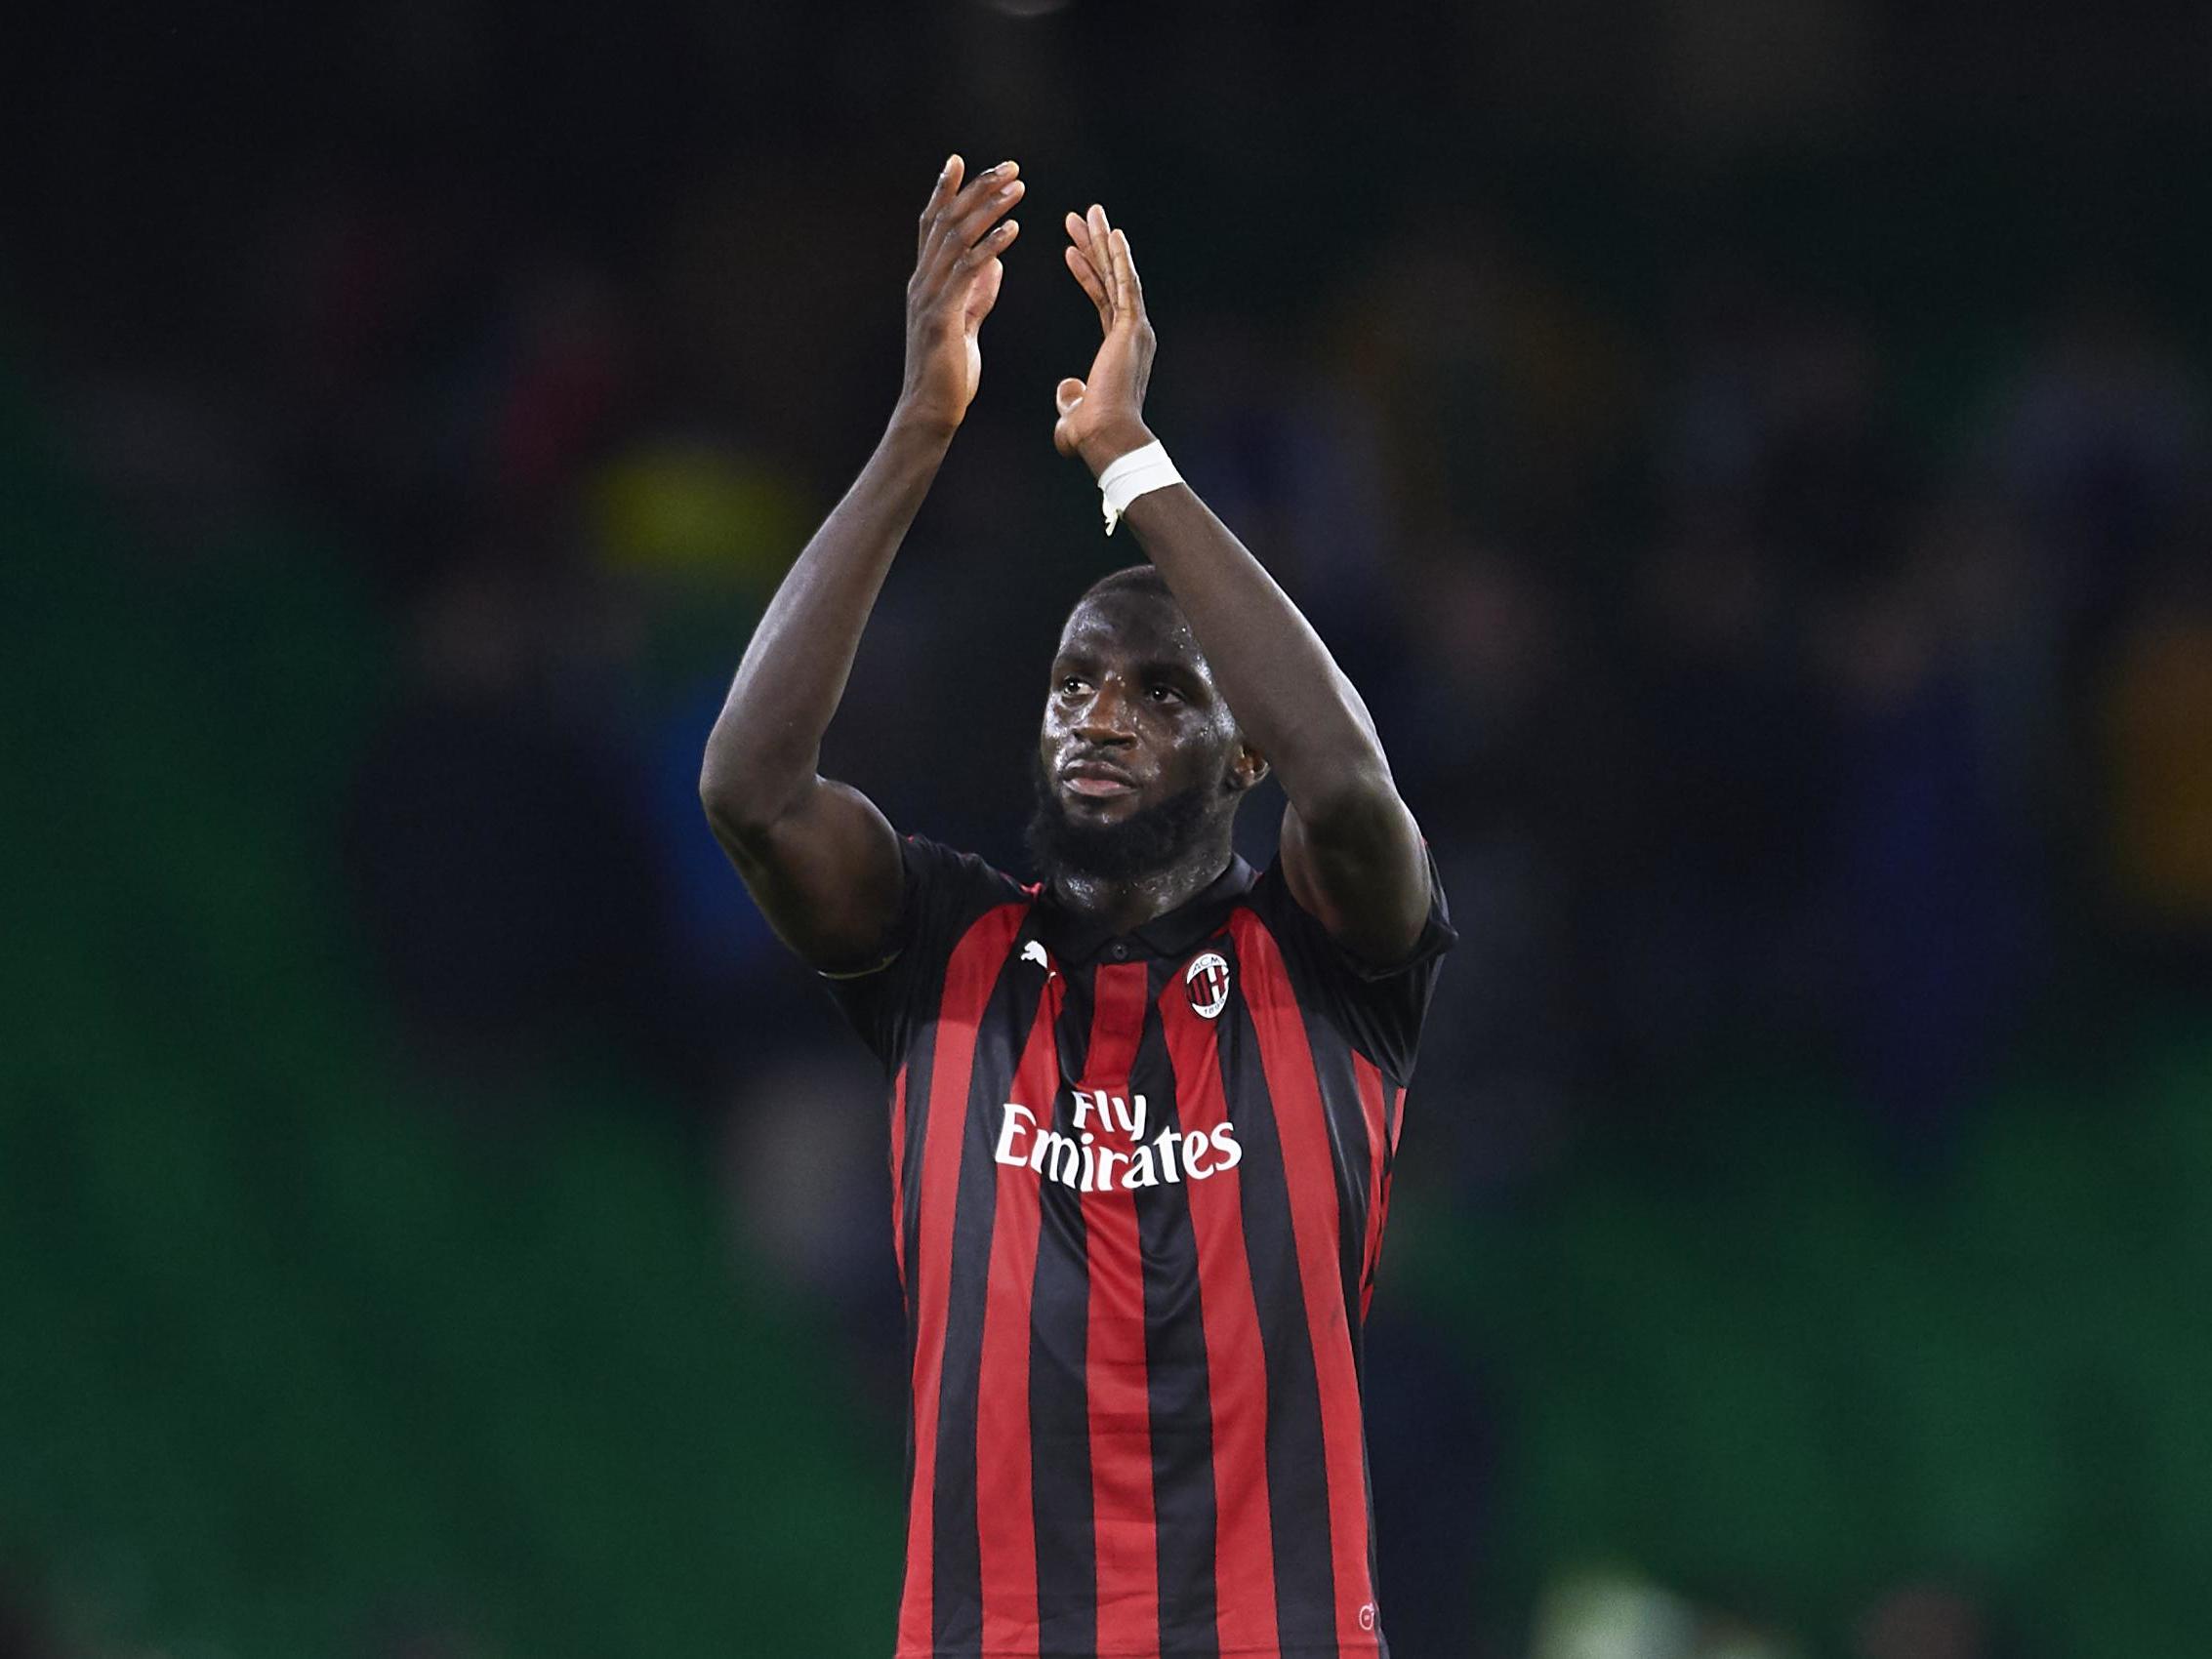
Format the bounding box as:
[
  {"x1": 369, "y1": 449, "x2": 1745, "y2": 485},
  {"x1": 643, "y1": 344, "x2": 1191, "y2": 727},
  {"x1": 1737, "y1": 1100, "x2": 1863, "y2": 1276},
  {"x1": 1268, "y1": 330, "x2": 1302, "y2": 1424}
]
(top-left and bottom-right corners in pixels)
[{"x1": 818, "y1": 836, "x2": 1029, "y2": 1071}]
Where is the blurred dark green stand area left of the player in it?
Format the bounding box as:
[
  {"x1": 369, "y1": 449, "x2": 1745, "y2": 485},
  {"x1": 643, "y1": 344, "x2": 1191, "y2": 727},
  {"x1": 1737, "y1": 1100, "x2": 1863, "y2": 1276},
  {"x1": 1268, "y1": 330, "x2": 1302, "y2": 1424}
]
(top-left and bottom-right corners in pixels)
[{"x1": 0, "y1": 383, "x2": 898, "y2": 1659}]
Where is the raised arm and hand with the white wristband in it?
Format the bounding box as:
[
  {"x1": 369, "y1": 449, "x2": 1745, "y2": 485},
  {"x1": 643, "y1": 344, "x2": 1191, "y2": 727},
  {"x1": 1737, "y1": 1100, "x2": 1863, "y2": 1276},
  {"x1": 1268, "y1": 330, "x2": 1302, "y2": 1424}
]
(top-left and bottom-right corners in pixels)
[{"x1": 1053, "y1": 206, "x2": 1429, "y2": 967}]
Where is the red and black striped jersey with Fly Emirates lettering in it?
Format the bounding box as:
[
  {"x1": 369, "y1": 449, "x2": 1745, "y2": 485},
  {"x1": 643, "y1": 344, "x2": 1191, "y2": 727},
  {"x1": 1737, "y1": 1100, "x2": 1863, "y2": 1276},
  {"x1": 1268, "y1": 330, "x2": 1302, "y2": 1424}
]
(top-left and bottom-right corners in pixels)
[{"x1": 830, "y1": 836, "x2": 1455, "y2": 1659}]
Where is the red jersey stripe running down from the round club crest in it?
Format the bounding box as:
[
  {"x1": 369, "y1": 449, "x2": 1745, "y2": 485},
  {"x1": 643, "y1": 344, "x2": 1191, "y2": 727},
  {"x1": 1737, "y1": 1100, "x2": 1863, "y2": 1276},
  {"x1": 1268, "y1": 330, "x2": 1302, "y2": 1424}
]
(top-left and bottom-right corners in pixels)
[{"x1": 1157, "y1": 973, "x2": 1281, "y2": 1654}]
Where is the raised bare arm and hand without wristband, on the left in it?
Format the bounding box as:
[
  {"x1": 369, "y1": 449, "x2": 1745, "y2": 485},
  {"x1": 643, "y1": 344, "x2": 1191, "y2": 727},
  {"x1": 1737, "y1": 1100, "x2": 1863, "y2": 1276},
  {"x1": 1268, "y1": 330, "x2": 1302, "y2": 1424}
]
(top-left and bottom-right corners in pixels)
[{"x1": 699, "y1": 155, "x2": 1022, "y2": 971}]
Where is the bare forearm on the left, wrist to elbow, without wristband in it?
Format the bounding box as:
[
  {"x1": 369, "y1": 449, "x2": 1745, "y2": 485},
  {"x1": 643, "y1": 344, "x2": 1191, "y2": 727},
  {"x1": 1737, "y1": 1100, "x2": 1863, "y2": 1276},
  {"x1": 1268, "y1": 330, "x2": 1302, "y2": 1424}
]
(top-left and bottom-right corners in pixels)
[{"x1": 699, "y1": 407, "x2": 951, "y2": 825}]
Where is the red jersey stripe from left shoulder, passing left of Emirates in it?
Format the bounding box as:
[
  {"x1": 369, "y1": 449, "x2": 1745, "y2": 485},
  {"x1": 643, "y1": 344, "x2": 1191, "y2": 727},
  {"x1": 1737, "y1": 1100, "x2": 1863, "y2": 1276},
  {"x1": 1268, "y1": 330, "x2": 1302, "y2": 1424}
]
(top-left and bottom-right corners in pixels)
[{"x1": 898, "y1": 905, "x2": 1029, "y2": 1654}]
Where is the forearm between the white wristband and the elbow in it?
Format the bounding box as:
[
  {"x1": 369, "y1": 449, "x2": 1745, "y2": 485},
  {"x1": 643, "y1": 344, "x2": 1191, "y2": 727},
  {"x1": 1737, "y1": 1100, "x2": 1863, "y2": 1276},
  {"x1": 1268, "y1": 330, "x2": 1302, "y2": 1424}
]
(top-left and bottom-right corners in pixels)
[{"x1": 1122, "y1": 470, "x2": 1389, "y2": 825}]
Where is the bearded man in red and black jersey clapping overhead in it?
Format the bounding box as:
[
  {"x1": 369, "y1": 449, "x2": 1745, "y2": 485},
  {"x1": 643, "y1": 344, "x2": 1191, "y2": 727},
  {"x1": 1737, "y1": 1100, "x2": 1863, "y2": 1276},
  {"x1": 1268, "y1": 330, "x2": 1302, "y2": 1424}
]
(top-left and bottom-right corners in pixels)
[{"x1": 699, "y1": 157, "x2": 1454, "y2": 1659}]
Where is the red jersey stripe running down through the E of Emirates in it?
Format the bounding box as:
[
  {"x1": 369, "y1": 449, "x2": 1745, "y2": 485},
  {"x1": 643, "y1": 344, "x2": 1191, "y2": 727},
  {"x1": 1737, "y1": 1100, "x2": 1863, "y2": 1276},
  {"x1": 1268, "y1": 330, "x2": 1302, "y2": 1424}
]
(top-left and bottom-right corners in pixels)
[{"x1": 971, "y1": 978, "x2": 1062, "y2": 1659}]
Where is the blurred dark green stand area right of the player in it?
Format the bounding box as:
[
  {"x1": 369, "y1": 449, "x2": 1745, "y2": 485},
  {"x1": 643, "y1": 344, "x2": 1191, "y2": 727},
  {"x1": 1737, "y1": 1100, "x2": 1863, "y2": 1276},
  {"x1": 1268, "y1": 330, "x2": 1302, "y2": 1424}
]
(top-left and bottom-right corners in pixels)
[{"x1": 1400, "y1": 1011, "x2": 2212, "y2": 1659}]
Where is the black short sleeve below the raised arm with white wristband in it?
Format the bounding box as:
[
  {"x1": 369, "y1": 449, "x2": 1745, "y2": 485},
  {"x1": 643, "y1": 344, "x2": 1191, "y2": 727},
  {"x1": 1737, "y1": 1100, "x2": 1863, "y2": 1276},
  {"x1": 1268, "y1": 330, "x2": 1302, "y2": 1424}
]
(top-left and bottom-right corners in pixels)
[{"x1": 1249, "y1": 843, "x2": 1460, "y2": 1086}]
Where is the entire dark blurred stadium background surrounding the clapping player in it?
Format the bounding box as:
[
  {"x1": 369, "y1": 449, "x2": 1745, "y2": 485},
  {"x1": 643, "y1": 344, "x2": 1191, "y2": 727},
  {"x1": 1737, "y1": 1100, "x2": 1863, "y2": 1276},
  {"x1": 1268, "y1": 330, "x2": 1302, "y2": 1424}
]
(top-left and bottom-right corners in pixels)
[{"x1": 0, "y1": 0, "x2": 2212, "y2": 1659}]
